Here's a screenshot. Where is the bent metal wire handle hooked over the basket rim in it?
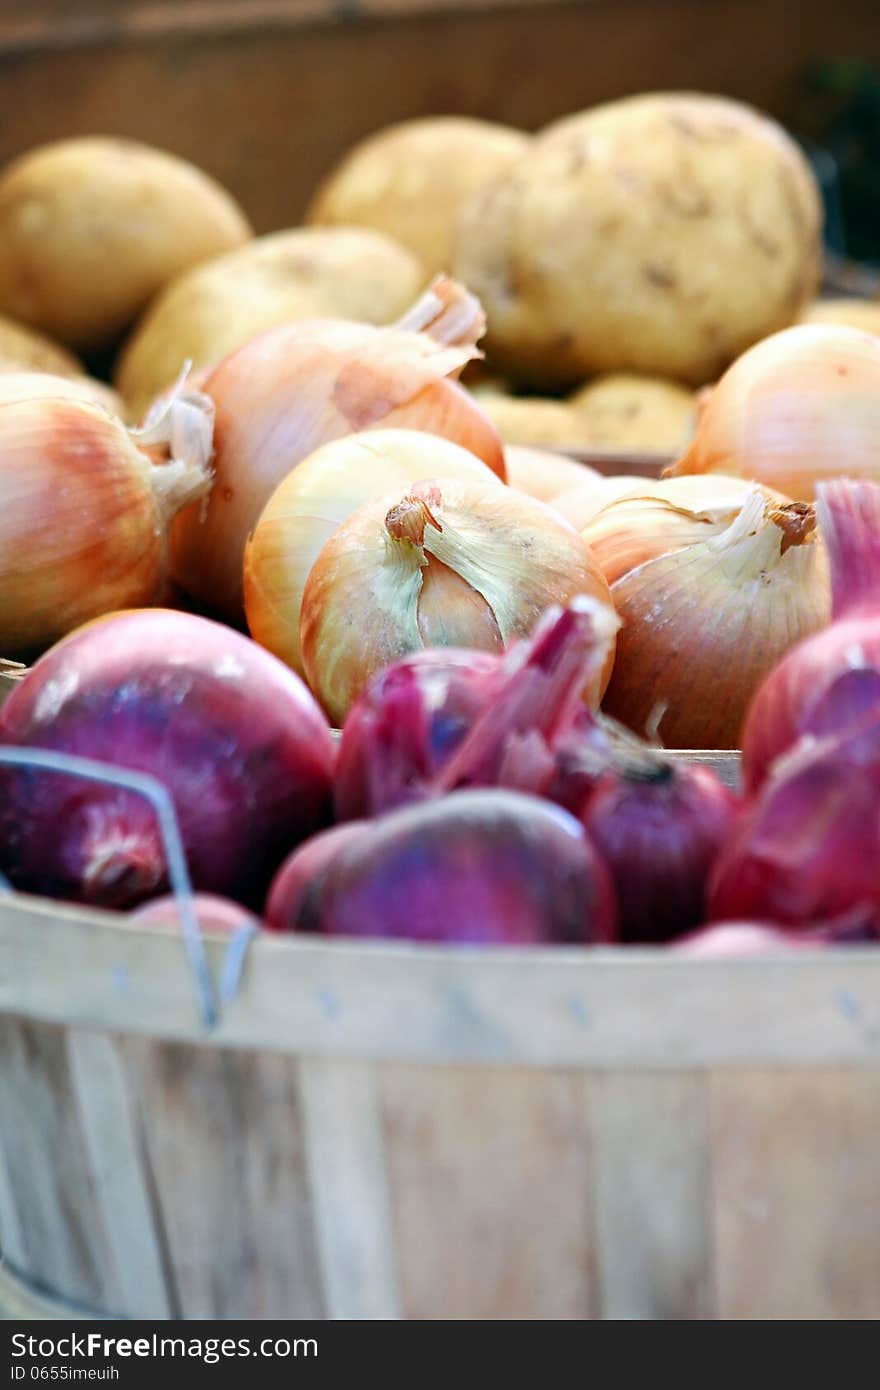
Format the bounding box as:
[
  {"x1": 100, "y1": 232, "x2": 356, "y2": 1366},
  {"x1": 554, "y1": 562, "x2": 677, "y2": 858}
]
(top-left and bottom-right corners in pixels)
[{"x1": 0, "y1": 748, "x2": 222, "y2": 1029}]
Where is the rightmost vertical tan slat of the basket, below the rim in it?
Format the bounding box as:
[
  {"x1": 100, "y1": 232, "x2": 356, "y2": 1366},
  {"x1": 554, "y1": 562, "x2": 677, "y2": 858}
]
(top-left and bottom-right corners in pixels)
[{"x1": 709, "y1": 1068, "x2": 880, "y2": 1321}]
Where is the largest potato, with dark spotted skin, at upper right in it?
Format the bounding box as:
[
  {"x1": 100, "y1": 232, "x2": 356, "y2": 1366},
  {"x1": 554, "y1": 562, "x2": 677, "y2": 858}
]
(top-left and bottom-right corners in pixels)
[{"x1": 455, "y1": 93, "x2": 822, "y2": 388}]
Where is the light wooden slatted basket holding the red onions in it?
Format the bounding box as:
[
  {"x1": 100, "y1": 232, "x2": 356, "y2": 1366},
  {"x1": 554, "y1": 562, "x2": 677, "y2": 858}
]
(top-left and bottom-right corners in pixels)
[{"x1": 0, "y1": 897, "x2": 880, "y2": 1319}]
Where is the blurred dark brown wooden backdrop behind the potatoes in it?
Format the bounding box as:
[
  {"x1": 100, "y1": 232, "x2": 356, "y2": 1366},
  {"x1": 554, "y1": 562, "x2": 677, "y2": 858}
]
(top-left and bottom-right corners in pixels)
[{"x1": 0, "y1": 0, "x2": 880, "y2": 231}]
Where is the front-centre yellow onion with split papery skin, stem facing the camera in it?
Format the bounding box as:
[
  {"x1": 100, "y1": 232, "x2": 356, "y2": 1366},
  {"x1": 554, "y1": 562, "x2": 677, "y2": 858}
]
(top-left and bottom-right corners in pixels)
[{"x1": 300, "y1": 480, "x2": 613, "y2": 721}]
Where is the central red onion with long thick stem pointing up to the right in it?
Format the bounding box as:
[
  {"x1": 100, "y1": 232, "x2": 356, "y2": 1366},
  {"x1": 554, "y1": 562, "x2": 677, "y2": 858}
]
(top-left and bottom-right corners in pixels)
[{"x1": 335, "y1": 596, "x2": 616, "y2": 817}]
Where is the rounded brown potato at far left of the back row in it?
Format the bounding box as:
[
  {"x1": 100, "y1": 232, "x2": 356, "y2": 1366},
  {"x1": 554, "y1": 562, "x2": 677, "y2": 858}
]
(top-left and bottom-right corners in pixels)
[{"x1": 0, "y1": 138, "x2": 252, "y2": 349}]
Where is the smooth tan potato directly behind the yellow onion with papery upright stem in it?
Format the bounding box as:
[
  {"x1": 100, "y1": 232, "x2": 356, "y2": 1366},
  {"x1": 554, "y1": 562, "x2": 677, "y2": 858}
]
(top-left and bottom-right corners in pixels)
[{"x1": 115, "y1": 228, "x2": 424, "y2": 418}]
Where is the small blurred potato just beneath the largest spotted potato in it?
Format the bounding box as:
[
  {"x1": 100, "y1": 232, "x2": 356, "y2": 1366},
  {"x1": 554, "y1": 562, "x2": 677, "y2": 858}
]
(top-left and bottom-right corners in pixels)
[{"x1": 570, "y1": 373, "x2": 696, "y2": 457}]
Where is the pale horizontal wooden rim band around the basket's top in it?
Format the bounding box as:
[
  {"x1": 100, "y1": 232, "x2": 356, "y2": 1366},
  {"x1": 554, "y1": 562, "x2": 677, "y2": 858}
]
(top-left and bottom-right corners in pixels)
[{"x1": 0, "y1": 897, "x2": 880, "y2": 1070}]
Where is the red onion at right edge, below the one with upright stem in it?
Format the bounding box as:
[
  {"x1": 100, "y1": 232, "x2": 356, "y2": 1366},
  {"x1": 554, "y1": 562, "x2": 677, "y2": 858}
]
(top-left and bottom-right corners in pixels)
[{"x1": 708, "y1": 710, "x2": 880, "y2": 926}]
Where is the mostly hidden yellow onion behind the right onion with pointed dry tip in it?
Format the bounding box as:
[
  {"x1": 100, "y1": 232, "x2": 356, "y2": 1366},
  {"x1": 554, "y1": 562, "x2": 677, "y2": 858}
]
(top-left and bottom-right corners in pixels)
[{"x1": 581, "y1": 473, "x2": 788, "y2": 584}]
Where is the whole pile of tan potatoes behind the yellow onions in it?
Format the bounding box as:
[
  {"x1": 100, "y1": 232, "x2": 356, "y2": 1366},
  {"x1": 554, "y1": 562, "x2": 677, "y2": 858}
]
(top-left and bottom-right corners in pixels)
[{"x1": 0, "y1": 93, "x2": 880, "y2": 456}]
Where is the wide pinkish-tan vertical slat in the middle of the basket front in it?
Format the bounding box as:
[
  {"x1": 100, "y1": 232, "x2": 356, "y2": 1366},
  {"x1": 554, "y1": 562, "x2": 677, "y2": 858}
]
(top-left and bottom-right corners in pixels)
[{"x1": 382, "y1": 1056, "x2": 599, "y2": 1321}]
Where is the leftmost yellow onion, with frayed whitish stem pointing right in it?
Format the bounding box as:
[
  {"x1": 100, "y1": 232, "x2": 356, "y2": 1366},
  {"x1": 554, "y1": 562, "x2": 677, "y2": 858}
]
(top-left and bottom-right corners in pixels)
[{"x1": 0, "y1": 374, "x2": 210, "y2": 652}]
